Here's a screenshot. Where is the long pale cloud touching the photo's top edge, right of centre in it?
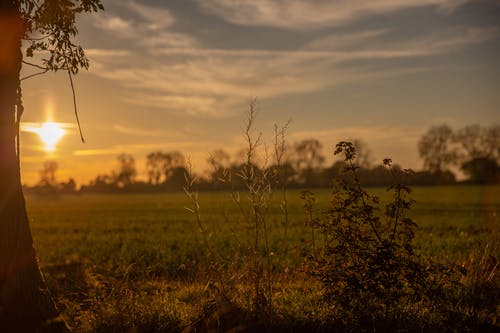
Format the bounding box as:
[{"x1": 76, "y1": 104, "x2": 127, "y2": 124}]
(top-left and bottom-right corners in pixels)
[{"x1": 197, "y1": 0, "x2": 467, "y2": 30}]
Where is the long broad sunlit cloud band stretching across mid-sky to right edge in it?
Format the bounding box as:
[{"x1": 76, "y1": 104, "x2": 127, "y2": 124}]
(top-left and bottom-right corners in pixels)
[{"x1": 83, "y1": 21, "x2": 500, "y2": 116}]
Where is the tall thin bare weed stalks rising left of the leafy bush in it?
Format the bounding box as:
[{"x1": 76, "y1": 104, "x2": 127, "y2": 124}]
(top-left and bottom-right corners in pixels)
[{"x1": 184, "y1": 99, "x2": 290, "y2": 320}]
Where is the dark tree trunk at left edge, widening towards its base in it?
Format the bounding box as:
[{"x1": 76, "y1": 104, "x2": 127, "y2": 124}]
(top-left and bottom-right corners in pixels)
[{"x1": 0, "y1": 0, "x2": 68, "y2": 332}]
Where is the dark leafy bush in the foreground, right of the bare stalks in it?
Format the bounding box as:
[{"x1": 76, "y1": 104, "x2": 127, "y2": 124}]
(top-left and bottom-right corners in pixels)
[{"x1": 303, "y1": 142, "x2": 453, "y2": 330}]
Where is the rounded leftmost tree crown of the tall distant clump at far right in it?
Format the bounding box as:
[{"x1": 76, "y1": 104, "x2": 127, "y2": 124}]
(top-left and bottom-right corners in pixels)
[{"x1": 418, "y1": 125, "x2": 457, "y2": 173}]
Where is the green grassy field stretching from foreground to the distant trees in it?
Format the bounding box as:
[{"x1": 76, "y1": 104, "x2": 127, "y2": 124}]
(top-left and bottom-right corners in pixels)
[{"x1": 27, "y1": 186, "x2": 500, "y2": 332}]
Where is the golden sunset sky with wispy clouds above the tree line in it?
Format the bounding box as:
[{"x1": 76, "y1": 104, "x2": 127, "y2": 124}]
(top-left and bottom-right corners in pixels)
[{"x1": 17, "y1": 0, "x2": 500, "y2": 184}]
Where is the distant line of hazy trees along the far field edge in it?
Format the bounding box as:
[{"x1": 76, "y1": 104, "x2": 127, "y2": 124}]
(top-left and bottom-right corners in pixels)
[{"x1": 25, "y1": 125, "x2": 500, "y2": 194}]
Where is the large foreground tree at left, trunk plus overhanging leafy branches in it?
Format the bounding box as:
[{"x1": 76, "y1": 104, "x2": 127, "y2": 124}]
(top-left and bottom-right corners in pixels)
[{"x1": 0, "y1": 0, "x2": 103, "y2": 332}]
